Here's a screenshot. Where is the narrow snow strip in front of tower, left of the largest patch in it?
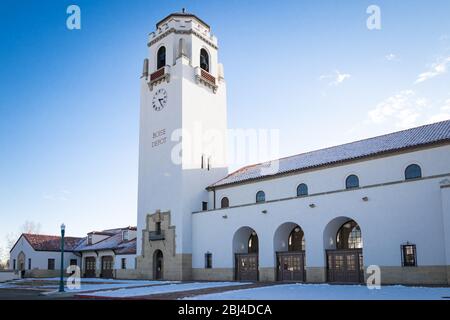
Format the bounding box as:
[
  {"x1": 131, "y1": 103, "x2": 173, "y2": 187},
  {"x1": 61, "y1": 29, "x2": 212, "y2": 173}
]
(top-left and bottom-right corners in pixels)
[{"x1": 84, "y1": 282, "x2": 247, "y2": 298}]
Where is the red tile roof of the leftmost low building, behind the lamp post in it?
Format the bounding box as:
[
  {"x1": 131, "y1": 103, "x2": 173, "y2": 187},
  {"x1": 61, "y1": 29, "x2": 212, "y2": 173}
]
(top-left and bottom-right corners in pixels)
[{"x1": 22, "y1": 233, "x2": 83, "y2": 251}]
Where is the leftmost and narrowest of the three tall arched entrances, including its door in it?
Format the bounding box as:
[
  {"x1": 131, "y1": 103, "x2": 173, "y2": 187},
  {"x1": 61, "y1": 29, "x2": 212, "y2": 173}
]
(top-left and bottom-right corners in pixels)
[{"x1": 233, "y1": 227, "x2": 259, "y2": 281}]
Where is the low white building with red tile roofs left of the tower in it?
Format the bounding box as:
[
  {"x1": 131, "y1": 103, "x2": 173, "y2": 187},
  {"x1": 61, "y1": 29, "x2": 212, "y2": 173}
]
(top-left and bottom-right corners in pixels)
[{"x1": 9, "y1": 227, "x2": 136, "y2": 278}]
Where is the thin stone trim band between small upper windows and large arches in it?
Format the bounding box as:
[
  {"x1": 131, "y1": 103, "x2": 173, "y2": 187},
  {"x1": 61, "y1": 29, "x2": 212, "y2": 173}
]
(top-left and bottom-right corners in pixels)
[{"x1": 192, "y1": 172, "x2": 450, "y2": 214}]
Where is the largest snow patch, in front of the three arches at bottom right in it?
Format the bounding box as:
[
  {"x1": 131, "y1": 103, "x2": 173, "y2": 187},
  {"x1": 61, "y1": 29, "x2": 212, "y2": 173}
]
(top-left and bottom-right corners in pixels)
[{"x1": 186, "y1": 284, "x2": 450, "y2": 300}]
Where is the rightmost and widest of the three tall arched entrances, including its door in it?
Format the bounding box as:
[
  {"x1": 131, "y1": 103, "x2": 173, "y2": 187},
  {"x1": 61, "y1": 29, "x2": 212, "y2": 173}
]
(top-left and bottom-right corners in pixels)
[{"x1": 323, "y1": 217, "x2": 364, "y2": 283}]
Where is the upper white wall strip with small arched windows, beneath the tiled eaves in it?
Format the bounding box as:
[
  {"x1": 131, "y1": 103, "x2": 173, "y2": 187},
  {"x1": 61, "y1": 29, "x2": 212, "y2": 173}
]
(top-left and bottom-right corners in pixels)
[{"x1": 210, "y1": 145, "x2": 450, "y2": 208}]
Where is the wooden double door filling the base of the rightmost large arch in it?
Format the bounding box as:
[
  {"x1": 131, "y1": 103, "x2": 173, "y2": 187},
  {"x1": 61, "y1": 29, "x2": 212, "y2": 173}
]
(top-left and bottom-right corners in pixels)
[{"x1": 327, "y1": 249, "x2": 364, "y2": 283}]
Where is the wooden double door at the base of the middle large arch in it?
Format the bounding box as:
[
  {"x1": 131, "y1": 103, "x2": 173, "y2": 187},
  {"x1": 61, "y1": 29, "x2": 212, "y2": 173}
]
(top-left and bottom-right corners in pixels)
[{"x1": 277, "y1": 251, "x2": 306, "y2": 282}]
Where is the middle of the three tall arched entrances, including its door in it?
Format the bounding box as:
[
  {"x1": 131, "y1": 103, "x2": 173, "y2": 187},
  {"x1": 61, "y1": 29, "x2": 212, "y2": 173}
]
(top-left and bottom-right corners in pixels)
[{"x1": 273, "y1": 222, "x2": 306, "y2": 282}]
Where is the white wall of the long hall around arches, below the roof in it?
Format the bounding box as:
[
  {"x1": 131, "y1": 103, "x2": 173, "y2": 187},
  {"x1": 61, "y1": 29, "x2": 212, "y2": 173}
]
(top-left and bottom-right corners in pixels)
[{"x1": 192, "y1": 146, "x2": 450, "y2": 268}]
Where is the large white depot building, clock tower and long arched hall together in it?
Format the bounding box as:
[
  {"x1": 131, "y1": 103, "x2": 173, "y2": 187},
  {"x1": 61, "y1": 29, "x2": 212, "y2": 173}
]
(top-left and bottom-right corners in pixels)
[{"x1": 134, "y1": 12, "x2": 450, "y2": 284}]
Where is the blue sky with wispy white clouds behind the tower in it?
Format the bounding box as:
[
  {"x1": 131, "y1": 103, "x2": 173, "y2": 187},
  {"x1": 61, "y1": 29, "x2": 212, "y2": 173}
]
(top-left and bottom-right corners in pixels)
[{"x1": 0, "y1": 0, "x2": 450, "y2": 258}]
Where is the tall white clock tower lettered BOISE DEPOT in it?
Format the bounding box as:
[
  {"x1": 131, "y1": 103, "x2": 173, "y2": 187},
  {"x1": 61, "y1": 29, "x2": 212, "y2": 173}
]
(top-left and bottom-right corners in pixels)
[{"x1": 136, "y1": 10, "x2": 228, "y2": 280}]
